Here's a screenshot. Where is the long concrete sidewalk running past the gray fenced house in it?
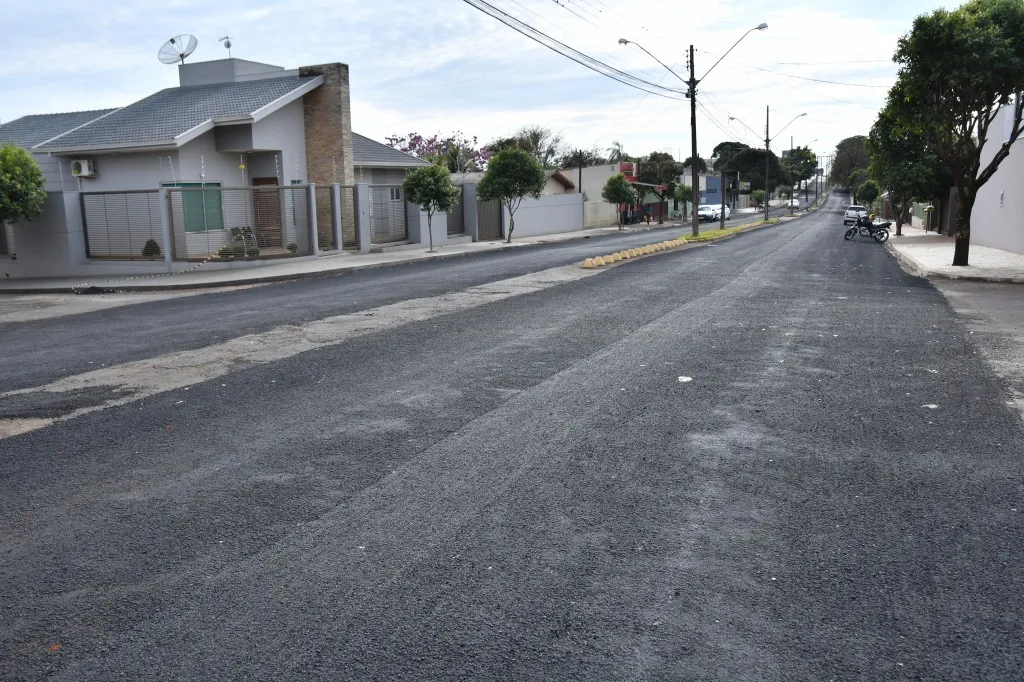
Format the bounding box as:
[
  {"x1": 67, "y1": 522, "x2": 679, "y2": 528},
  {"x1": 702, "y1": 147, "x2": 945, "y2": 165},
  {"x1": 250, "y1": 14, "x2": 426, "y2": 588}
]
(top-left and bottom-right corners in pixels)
[{"x1": 0, "y1": 221, "x2": 683, "y2": 294}]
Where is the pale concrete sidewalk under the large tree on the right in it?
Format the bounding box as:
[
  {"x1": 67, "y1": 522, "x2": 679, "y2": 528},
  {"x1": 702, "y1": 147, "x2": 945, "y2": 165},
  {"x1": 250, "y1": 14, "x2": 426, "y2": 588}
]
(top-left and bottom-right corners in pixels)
[{"x1": 886, "y1": 225, "x2": 1024, "y2": 284}]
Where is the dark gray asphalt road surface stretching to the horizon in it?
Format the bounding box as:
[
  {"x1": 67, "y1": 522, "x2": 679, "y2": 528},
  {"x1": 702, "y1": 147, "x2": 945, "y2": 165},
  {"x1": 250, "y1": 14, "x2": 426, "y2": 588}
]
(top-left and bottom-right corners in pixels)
[{"x1": 0, "y1": 193, "x2": 1024, "y2": 681}]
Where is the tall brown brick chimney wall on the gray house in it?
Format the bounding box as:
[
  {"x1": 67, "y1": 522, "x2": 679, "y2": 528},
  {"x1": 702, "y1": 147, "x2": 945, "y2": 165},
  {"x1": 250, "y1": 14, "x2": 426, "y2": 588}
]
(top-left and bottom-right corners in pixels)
[{"x1": 299, "y1": 63, "x2": 355, "y2": 184}]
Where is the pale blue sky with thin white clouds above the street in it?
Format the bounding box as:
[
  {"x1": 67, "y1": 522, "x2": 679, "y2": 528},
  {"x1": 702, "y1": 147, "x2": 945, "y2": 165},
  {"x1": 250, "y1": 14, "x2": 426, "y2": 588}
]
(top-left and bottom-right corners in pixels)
[{"x1": 0, "y1": 0, "x2": 941, "y2": 160}]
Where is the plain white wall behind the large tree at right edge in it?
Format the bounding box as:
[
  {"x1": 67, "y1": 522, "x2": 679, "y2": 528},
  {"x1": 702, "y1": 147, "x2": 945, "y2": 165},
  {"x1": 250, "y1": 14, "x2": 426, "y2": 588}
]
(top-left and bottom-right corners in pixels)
[{"x1": 966, "y1": 106, "x2": 1024, "y2": 253}]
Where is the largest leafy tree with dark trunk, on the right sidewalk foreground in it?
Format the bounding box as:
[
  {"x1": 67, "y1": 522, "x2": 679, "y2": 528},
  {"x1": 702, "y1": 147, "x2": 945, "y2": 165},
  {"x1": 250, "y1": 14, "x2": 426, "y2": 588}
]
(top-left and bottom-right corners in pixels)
[{"x1": 887, "y1": 0, "x2": 1024, "y2": 265}]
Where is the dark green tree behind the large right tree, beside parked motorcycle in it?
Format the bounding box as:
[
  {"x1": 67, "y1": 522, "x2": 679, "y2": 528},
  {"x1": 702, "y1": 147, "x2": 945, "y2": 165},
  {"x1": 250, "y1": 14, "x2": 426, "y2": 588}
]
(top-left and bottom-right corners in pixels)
[{"x1": 867, "y1": 91, "x2": 953, "y2": 237}]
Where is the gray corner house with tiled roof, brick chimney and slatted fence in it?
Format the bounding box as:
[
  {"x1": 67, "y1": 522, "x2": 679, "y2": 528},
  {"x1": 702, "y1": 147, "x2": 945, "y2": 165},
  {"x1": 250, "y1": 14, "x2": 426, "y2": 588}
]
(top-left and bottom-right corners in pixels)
[{"x1": 0, "y1": 59, "x2": 423, "y2": 278}]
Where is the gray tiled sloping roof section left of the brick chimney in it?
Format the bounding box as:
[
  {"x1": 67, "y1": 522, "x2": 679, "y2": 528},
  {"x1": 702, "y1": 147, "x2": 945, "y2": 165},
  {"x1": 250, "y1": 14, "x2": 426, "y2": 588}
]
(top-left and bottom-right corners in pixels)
[{"x1": 35, "y1": 76, "x2": 324, "y2": 152}]
